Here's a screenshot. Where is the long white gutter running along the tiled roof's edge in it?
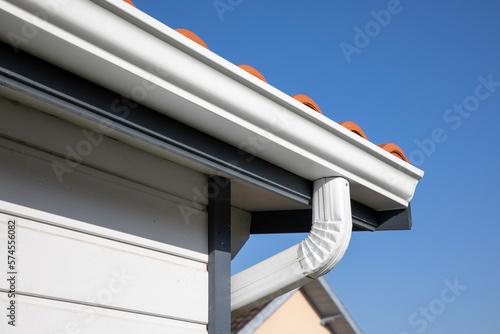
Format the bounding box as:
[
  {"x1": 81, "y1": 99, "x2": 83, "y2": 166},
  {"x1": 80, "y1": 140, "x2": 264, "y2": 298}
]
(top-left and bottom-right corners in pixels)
[{"x1": 0, "y1": 0, "x2": 423, "y2": 210}]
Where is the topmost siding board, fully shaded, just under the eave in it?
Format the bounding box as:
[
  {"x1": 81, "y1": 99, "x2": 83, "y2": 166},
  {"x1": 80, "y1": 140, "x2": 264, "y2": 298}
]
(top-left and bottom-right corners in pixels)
[{"x1": 0, "y1": 94, "x2": 207, "y2": 205}]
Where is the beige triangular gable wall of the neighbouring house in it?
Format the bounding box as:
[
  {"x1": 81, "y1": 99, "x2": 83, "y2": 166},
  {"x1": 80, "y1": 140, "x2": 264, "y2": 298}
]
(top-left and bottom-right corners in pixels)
[{"x1": 255, "y1": 291, "x2": 330, "y2": 334}]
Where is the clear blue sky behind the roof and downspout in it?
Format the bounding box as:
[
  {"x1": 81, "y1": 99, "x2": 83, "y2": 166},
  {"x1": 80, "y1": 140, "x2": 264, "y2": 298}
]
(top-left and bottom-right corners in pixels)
[{"x1": 134, "y1": 0, "x2": 500, "y2": 334}]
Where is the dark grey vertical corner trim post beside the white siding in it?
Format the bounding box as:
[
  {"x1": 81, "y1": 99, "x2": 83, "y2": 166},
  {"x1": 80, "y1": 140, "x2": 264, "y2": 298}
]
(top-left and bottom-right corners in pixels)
[{"x1": 207, "y1": 176, "x2": 231, "y2": 334}]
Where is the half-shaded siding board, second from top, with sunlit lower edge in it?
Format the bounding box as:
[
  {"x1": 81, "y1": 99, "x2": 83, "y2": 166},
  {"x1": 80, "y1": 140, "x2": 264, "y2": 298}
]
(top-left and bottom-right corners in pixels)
[{"x1": 0, "y1": 138, "x2": 208, "y2": 262}]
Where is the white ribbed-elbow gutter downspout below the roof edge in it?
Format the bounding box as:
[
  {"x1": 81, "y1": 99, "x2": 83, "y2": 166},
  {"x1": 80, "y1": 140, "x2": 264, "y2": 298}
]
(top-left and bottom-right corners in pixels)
[{"x1": 231, "y1": 177, "x2": 352, "y2": 316}]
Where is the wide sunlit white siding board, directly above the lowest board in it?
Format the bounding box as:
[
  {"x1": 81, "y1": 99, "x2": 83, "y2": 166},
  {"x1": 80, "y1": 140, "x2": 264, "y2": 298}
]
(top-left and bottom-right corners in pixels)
[{"x1": 0, "y1": 214, "x2": 208, "y2": 322}]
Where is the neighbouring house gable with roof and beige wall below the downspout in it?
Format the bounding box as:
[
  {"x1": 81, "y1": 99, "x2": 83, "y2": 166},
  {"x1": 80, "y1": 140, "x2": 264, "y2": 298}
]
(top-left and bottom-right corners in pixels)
[{"x1": 231, "y1": 277, "x2": 362, "y2": 334}]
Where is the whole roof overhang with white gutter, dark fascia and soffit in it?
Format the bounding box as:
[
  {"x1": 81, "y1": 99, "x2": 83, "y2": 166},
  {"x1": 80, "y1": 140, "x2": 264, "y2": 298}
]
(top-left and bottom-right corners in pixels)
[{"x1": 0, "y1": 0, "x2": 423, "y2": 233}]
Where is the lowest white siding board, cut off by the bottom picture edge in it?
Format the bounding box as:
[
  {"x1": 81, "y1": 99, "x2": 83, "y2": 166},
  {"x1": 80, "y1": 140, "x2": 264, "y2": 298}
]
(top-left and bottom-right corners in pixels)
[{"x1": 0, "y1": 292, "x2": 207, "y2": 334}]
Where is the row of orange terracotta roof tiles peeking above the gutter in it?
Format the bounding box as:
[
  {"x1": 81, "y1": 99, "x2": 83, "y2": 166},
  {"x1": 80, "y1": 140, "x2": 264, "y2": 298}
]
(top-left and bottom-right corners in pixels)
[{"x1": 128, "y1": 0, "x2": 409, "y2": 163}]
